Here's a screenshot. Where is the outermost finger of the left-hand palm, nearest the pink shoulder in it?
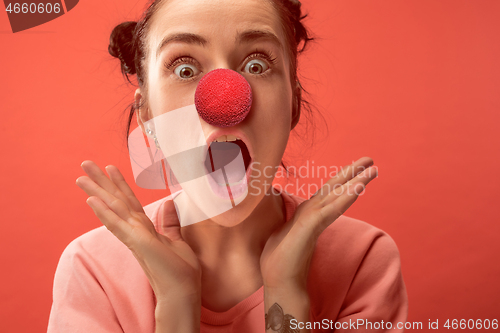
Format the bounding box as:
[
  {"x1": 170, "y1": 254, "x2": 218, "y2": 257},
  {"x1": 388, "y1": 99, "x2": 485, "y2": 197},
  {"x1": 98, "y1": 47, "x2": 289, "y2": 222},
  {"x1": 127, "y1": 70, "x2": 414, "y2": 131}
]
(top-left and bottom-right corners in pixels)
[{"x1": 87, "y1": 196, "x2": 133, "y2": 248}]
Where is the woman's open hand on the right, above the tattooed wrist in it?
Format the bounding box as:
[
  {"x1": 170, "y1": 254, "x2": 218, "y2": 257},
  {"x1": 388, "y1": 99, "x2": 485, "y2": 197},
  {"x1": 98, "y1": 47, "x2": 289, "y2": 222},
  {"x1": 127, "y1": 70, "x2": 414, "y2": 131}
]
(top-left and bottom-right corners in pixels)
[{"x1": 260, "y1": 157, "x2": 378, "y2": 291}]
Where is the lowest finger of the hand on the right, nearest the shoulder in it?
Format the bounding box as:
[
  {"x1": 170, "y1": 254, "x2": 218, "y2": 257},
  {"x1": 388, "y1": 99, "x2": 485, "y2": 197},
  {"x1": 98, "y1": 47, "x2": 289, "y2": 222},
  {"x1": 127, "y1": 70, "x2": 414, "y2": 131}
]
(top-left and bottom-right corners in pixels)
[{"x1": 319, "y1": 182, "x2": 365, "y2": 233}]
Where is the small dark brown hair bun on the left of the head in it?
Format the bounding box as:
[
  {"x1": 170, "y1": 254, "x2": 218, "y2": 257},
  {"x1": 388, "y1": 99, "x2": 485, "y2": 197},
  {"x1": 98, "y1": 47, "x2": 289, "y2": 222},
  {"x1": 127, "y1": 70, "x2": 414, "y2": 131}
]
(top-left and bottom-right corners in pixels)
[{"x1": 108, "y1": 21, "x2": 137, "y2": 75}]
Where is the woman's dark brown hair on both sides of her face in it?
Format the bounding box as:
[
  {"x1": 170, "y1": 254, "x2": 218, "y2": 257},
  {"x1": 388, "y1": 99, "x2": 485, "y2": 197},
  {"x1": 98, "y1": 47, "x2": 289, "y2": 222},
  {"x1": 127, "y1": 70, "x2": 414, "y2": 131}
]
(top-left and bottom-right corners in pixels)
[{"x1": 108, "y1": 0, "x2": 315, "y2": 150}]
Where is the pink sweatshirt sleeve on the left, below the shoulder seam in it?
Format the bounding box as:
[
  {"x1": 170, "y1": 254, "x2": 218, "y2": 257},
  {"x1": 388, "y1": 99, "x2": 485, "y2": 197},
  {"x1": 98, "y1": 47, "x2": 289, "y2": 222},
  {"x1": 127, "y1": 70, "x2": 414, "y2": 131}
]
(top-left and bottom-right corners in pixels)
[{"x1": 47, "y1": 238, "x2": 123, "y2": 333}]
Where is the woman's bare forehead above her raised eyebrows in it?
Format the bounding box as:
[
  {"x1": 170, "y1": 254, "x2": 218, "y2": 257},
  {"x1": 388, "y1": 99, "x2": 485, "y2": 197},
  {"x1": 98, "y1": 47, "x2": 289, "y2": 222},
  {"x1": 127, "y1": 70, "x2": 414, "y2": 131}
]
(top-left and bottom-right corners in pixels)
[{"x1": 148, "y1": 0, "x2": 284, "y2": 56}]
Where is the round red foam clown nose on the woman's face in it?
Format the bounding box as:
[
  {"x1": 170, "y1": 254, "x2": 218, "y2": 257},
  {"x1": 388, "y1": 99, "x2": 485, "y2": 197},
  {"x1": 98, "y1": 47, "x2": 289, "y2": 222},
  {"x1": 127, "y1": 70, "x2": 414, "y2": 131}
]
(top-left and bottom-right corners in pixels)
[{"x1": 194, "y1": 68, "x2": 252, "y2": 127}]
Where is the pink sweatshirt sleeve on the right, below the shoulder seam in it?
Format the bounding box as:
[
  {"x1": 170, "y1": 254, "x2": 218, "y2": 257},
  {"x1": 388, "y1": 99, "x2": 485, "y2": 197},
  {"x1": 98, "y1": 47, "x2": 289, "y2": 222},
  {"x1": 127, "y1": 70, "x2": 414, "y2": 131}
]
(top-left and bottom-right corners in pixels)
[{"x1": 335, "y1": 230, "x2": 408, "y2": 332}]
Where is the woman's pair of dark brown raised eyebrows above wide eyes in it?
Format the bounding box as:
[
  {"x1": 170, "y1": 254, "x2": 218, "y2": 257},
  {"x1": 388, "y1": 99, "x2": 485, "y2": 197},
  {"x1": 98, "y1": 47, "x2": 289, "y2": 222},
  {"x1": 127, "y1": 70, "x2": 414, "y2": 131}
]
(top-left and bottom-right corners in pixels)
[{"x1": 156, "y1": 30, "x2": 283, "y2": 58}]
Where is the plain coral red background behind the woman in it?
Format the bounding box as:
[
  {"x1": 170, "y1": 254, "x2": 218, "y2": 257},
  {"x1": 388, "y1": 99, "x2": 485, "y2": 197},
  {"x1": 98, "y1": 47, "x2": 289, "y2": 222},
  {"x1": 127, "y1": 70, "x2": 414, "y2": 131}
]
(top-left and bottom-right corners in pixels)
[{"x1": 0, "y1": 0, "x2": 500, "y2": 333}]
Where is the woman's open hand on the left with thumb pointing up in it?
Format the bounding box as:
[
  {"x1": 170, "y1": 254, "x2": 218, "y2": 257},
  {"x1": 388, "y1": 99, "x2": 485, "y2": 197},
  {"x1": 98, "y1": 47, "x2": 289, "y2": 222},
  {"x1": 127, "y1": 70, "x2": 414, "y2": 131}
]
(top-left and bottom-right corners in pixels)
[{"x1": 76, "y1": 161, "x2": 201, "y2": 303}]
